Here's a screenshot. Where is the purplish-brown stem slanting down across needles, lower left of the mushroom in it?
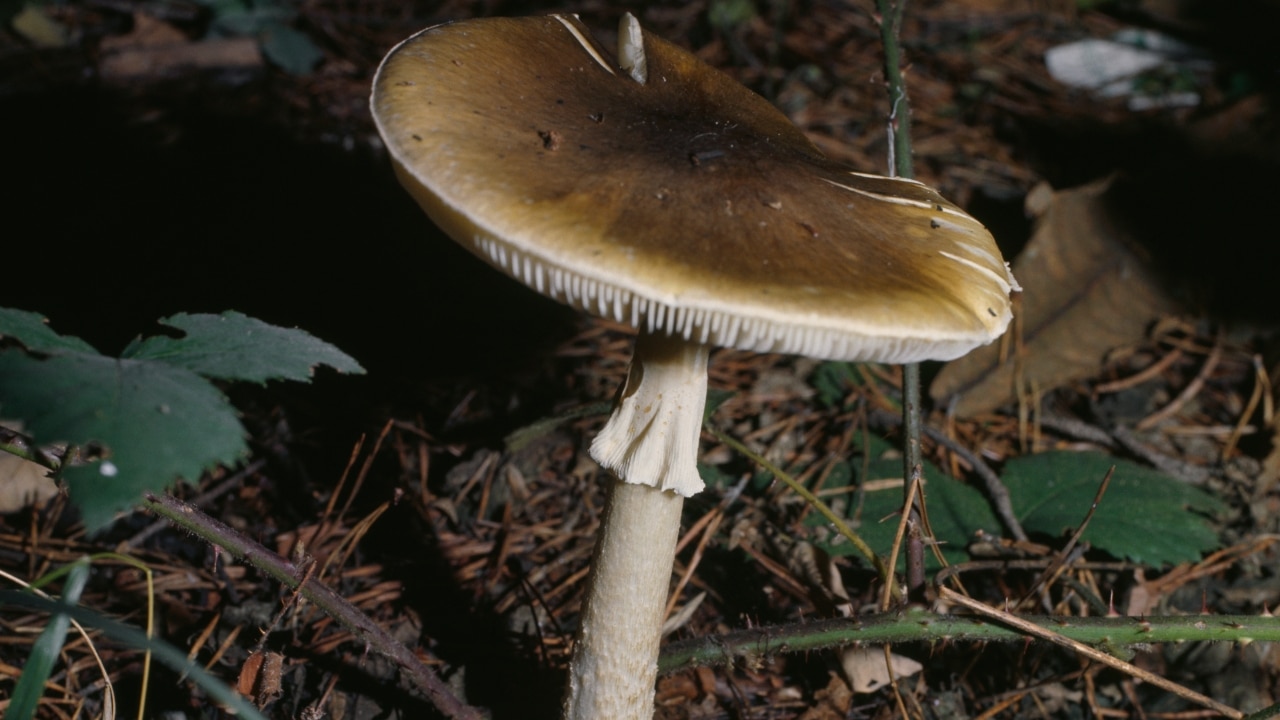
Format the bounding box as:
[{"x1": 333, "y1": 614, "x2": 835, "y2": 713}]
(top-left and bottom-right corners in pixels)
[{"x1": 146, "y1": 493, "x2": 481, "y2": 720}]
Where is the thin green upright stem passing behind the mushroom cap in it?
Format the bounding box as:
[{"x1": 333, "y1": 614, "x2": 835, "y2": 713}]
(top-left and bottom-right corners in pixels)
[{"x1": 876, "y1": 0, "x2": 924, "y2": 601}]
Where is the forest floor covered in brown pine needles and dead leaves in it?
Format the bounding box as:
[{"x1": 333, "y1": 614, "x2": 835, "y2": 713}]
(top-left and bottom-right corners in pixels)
[{"x1": 0, "y1": 0, "x2": 1280, "y2": 720}]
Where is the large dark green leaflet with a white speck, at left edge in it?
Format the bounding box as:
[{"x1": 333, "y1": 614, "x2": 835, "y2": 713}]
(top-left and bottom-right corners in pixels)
[{"x1": 0, "y1": 351, "x2": 248, "y2": 530}]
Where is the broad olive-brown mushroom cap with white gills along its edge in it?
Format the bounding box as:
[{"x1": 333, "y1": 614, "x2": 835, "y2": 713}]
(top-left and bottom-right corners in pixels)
[{"x1": 372, "y1": 15, "x2": 1016, "y2": 363}]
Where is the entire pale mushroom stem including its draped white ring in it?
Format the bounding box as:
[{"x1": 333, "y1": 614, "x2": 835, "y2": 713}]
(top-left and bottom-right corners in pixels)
[{"x1": 563, "y1": 333, "x2": 710, "y2": 720}]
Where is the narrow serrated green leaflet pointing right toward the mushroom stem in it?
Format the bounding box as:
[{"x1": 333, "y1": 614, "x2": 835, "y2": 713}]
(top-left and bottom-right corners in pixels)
[{"x1": 123, "y1": 311, "x2": 365, "y2": 383}]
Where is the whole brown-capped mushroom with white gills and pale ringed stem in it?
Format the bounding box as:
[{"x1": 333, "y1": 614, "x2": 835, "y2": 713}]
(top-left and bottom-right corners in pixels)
[{"x1": 372, "y1": 15, "x2": 1015, "y2": 720}]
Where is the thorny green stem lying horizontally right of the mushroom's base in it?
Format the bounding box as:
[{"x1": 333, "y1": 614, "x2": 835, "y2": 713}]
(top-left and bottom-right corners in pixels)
[{"x1": 658, "y1": 606, "x2": 1280, "y2": 673}]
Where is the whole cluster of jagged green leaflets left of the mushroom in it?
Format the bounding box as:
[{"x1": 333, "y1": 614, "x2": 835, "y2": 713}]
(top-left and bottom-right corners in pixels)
[{"x1": 0, "y1": 309, "x2": 364, "y2": 530}]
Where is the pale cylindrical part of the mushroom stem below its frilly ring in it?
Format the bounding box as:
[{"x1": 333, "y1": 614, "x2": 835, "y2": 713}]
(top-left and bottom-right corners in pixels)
[{"x1": 563, "y1": 480, "x2": 685, "y2": 720}]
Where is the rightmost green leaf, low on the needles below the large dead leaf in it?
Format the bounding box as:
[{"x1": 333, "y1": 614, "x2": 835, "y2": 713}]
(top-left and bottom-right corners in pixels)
[{"x1": 1002, "y1": 452, "x2": 1226, "y2": 566}]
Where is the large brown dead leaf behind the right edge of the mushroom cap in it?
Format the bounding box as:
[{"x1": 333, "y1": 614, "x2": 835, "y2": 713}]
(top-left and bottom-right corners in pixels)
[{"x1": 929, "y1": 178, "x2": 1176, "y2": 416}]
